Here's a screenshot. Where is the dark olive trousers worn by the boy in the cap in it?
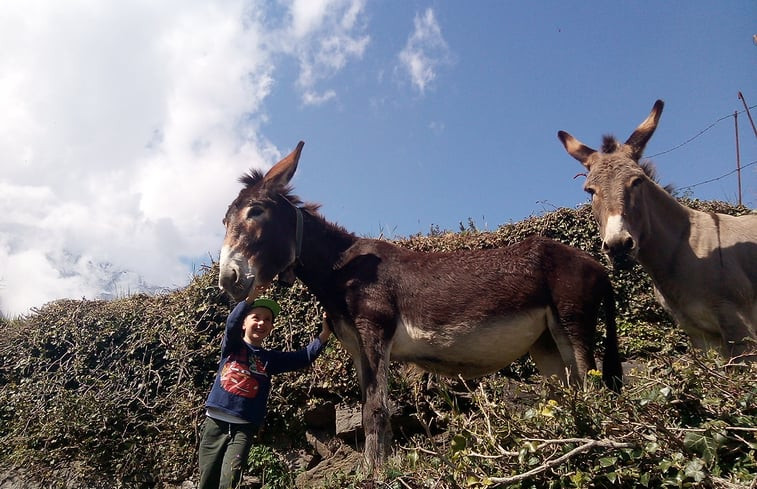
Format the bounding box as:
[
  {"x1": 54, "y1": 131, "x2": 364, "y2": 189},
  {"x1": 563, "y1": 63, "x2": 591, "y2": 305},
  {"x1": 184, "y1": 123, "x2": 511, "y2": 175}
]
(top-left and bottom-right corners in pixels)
[{"x1": 198, "y1": 417, "x2": 258, "y2": 489}]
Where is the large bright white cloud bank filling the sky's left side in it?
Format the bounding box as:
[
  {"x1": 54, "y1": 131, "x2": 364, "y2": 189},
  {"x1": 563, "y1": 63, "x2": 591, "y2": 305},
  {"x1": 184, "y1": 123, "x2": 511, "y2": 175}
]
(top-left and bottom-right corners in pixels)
[{"x1": 0, "y1": 0, "x2": 367, "y2": 315}]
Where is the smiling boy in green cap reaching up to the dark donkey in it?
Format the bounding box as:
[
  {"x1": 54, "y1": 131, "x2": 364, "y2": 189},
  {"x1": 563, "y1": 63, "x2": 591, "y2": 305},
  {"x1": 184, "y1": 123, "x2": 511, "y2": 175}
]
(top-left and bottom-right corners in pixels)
[{"x1": 199, "y1": 298, "x2": 331, "y2": 489}]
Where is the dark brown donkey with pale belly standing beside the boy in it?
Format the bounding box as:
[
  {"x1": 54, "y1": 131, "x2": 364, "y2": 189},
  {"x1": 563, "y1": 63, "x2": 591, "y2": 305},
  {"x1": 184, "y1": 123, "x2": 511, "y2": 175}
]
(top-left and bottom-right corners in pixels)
[{"x1": 219, "y1": 143, "x2": 622, "y2": 471}]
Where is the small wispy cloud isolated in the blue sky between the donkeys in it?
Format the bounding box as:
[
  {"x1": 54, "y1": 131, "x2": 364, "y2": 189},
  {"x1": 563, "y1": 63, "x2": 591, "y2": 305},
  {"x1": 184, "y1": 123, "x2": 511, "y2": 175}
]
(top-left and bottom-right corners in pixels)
[{"x1": 399, "y1": 8, "x2": 451, "y2": 94}]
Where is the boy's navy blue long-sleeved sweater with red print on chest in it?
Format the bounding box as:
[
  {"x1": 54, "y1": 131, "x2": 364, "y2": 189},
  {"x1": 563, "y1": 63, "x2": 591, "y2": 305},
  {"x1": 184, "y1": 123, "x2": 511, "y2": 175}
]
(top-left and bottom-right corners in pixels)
[{"x1": 205, "y1": 301, "x2": 325, "y2": 426}]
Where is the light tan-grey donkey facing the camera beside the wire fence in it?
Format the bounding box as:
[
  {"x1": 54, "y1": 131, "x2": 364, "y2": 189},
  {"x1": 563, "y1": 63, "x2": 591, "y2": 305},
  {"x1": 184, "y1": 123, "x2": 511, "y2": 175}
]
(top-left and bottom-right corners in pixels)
[{"x1": 557, "y1": 100, "x2": 757, "y2": 357}]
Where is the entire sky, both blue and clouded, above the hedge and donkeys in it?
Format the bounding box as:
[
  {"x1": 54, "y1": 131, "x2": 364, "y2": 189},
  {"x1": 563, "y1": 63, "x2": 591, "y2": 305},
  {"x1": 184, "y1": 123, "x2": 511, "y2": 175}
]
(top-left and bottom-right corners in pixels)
[{"x1": 0, "y1": 0, "x2": 757, "y2": 315}]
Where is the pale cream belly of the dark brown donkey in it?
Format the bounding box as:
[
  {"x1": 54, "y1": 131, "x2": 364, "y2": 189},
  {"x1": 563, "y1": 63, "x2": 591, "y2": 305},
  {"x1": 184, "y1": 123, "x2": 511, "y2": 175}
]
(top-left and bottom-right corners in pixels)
[{"x1": 391, "y1": 308, "x2": 551, "y2": 378}]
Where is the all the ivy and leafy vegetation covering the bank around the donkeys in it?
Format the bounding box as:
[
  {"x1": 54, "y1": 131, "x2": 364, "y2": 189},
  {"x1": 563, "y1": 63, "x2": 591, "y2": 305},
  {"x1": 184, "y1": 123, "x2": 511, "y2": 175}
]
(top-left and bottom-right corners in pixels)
[{"x1": 0, "y1": 201, "x2": 757, "y2": 489}]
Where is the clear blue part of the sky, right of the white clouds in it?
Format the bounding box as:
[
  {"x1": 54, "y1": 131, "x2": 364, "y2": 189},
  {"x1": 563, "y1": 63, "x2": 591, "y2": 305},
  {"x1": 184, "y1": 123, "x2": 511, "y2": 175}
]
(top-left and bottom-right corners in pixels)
[{"x1": 268, "y1": 2, "x2": 757, "y2": 236}]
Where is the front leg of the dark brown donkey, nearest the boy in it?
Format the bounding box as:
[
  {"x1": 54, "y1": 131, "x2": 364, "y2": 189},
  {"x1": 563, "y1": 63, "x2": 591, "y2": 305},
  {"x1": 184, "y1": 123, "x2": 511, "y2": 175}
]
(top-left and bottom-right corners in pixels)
[{"x1": 361, "y1": 331, "x2": 389, "y2": 474}]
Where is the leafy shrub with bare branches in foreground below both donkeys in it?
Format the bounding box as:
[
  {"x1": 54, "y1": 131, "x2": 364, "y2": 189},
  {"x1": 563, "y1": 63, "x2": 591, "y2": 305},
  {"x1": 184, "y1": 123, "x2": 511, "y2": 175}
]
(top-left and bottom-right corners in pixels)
[{"x1": 364, "y1": 352, "x2": 757, "y2": 489}]
